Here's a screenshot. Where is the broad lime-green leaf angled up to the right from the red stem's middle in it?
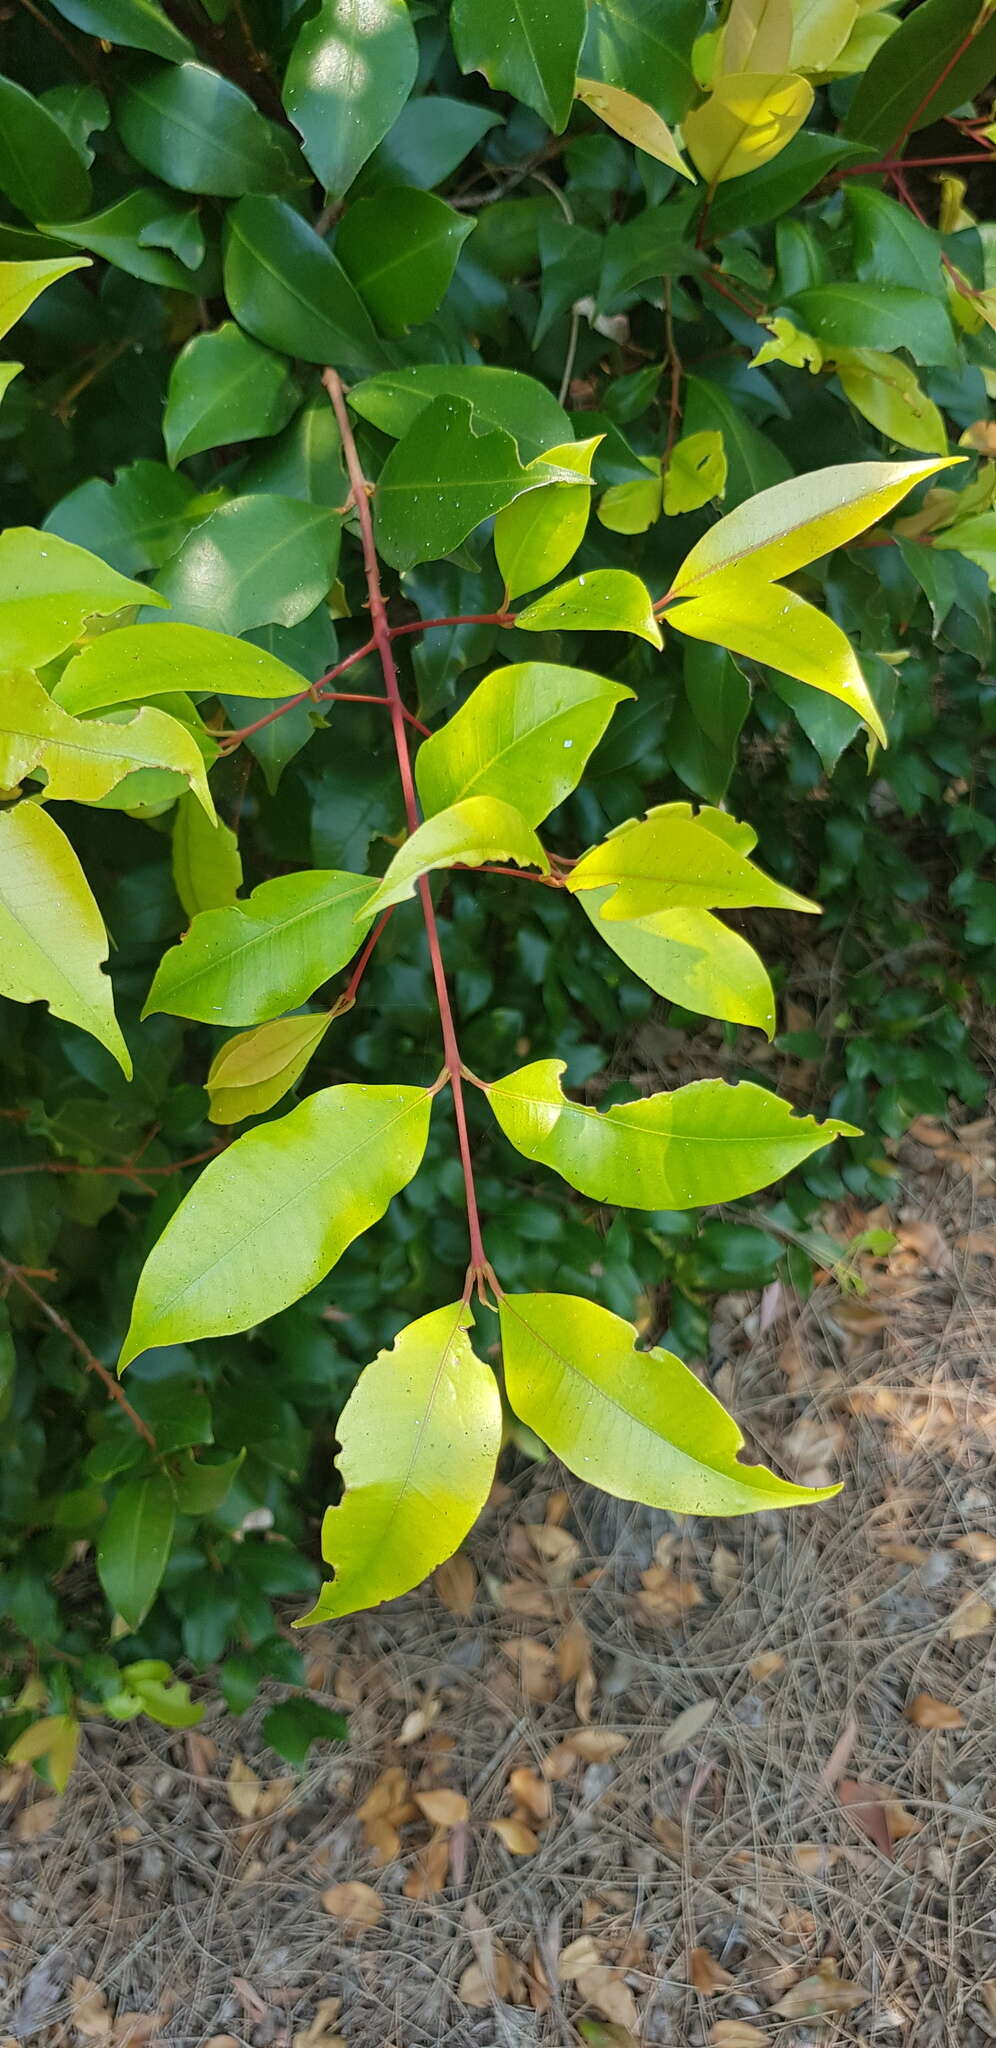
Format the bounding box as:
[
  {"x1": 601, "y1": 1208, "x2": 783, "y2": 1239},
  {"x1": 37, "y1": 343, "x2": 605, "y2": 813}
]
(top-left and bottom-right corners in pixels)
[{"x1": 416, "y1": 662, "x2": 633, "y2": 825}]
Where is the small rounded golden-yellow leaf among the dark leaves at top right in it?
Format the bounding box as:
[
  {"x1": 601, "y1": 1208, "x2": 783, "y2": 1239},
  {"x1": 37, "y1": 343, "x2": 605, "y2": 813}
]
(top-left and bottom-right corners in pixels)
[{"x1": 684, "y1": 72, "x2": 814, "y2": 184}]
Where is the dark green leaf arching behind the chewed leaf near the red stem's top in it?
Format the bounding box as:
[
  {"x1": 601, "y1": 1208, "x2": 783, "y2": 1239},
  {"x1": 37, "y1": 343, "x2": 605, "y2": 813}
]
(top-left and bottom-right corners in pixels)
[{"x1": 348, "y1": 362, "x2": 572, "y2": 463}]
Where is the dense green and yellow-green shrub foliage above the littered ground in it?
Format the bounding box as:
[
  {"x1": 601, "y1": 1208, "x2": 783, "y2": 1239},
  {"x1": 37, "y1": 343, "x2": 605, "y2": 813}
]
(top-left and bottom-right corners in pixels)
[{"x1": 0, "y1": 0, "x2": 996, "y2": 1784}]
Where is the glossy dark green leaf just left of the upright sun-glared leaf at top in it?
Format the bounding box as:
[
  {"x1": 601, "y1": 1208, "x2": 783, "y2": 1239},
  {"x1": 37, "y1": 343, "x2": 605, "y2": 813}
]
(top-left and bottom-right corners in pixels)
[{"x1": 117, "y1": 63, "x2": 293, "y2": 196}]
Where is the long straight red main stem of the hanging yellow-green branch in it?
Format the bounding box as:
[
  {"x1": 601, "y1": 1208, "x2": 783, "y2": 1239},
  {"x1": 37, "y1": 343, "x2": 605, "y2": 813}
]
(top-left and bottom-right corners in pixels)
[{"x1": 322, "y1": 369, "x2": 488, "y2": 1278}]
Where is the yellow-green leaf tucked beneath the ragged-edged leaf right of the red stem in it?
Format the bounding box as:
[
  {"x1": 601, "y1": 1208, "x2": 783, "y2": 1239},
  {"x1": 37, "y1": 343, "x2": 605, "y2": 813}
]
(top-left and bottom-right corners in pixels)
[{"x1": 580, "y1": 889, "x2": 775, "y2": 1038}]
